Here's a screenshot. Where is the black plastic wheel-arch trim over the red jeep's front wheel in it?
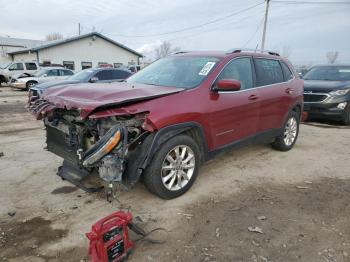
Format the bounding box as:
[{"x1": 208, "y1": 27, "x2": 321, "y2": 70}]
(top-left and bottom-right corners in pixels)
[{"x1": 125, "y1": 122, "x2": 208, "y2": 186}]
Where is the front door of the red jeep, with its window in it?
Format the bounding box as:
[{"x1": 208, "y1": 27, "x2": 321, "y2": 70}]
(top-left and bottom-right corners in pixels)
[{"x1": 209, "y1": 57, "x2": 259, "y2": 148}]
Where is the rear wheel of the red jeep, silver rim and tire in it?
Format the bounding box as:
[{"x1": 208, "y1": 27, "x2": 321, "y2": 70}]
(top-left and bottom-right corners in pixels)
[{"x1": 272, "y1": 111, "x2": 300, "y2": 151}]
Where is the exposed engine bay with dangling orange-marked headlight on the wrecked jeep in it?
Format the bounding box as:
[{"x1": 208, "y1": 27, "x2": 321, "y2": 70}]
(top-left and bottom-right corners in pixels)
[{"x1": 44, "y1": 108, "x2": 149, "y2": 202}]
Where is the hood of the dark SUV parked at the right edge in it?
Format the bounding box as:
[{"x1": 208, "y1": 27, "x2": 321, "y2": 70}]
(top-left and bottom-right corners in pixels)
[{"x1": 304, "y1": 80, "x2": 350, "y2": 93}]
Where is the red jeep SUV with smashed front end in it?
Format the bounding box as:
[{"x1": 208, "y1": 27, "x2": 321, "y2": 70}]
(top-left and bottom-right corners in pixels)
[{"x1": 29, "y1": 50, "x2": 303, "y2": 199}]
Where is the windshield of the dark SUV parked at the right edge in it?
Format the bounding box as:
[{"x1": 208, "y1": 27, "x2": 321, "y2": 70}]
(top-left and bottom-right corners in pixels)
[{"x1": 303, "y1": 66, "x2": 350, "y2": 81}]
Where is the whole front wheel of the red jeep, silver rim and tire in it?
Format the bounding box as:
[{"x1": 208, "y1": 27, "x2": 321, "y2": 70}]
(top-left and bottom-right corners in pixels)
[{"x1": 144, "y1": 135, "x2": 201, "y2": 199}]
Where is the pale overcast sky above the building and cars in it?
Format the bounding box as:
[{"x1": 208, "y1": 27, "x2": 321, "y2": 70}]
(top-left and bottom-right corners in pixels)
[{"x1": 0, "y1": 0, "x2": 350, "y2": 64}]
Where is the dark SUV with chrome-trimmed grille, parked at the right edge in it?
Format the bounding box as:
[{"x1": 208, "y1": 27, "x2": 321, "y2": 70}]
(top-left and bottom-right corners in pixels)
[{"x1": 303, "y1": 65, "x2": 350, "y2": 125}]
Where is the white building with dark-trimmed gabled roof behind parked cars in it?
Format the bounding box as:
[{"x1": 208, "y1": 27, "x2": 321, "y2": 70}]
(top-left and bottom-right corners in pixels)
[{"x1": 8, "y1": 32, "x2": 142, "y2": 71}]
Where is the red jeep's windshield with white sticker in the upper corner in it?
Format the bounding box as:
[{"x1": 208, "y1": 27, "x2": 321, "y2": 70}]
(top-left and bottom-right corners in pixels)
[{"x1": 126, "y1": 56, "x2": 219, "y2": 89}]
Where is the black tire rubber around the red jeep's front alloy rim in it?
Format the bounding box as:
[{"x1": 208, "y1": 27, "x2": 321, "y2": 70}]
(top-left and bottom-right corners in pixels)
[{"x1": 143, "y1": 135, "x2": 201, "y2": 199}]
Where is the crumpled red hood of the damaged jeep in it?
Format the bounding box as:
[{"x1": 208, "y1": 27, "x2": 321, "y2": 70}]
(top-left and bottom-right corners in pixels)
[{"x1": 42, "y1": 82, "x2": 184, "y2": 118}]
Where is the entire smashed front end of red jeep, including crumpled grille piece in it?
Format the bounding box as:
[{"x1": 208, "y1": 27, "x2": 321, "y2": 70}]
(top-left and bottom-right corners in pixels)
[{"x1": 29, "y1": 99, "x2": 152, "y2": 199}]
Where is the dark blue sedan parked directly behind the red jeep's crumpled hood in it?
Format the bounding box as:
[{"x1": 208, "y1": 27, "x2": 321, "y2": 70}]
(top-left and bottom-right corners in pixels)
[{"x1": 29, "y1": 68, "x2": 131, "y2": 97}]
